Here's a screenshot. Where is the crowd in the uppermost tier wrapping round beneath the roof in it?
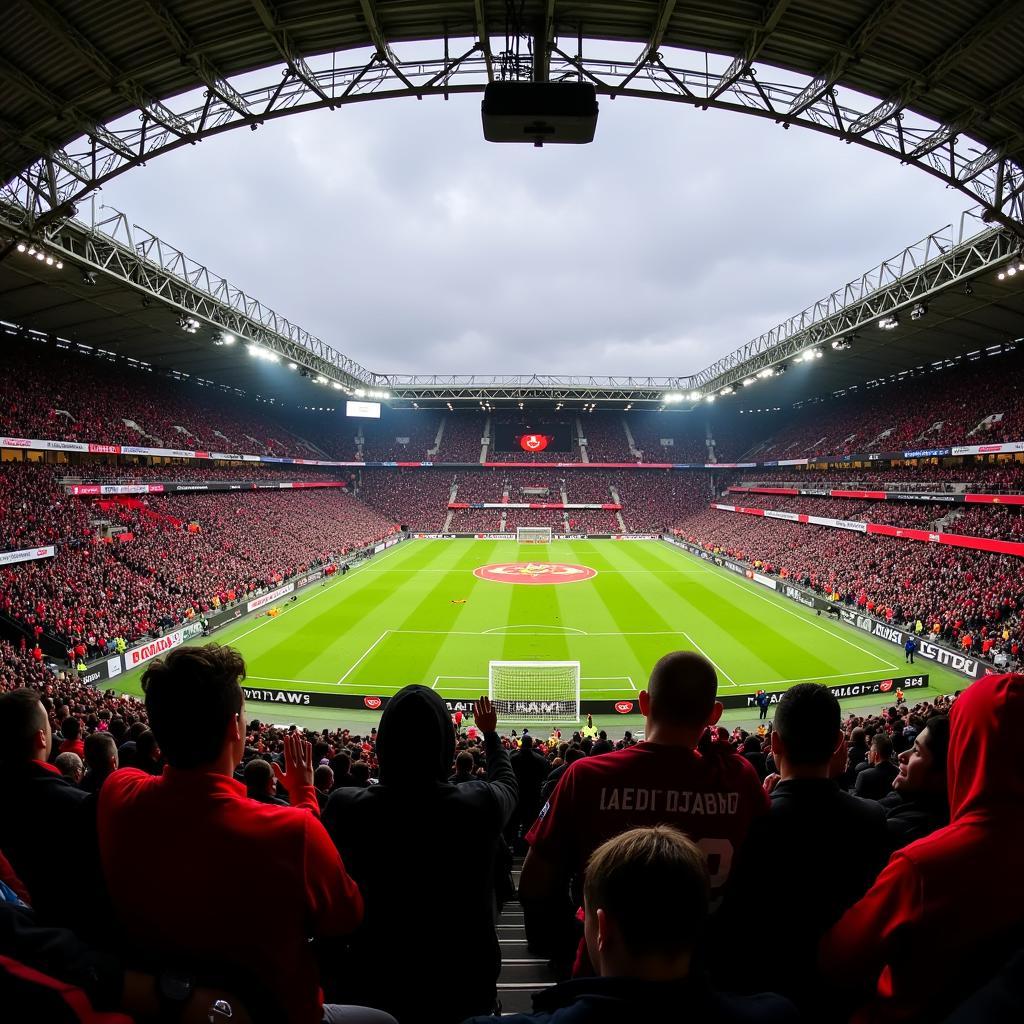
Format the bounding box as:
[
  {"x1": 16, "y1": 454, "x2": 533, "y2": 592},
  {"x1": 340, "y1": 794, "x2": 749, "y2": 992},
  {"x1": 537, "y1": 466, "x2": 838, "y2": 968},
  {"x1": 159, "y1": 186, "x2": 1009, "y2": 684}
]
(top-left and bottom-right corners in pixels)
[{"x1": 8, "y1": 341, "x2": 1024, "y2": 463}]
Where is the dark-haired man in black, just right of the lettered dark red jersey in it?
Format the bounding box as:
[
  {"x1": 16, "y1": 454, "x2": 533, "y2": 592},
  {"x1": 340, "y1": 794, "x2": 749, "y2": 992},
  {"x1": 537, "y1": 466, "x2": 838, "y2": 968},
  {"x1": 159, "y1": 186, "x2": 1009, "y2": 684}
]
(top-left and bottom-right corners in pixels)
[{"x1": 713, "y1": 683, "x2": 889, "y2": 1020}]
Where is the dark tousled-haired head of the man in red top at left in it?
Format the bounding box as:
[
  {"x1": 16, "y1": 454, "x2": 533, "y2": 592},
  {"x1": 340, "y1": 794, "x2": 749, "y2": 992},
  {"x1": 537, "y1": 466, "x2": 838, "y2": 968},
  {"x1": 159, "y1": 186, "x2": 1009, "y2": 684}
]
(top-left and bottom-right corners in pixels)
[{"x1": 142, "y1": 643, "x2": 246, "y2": 769}]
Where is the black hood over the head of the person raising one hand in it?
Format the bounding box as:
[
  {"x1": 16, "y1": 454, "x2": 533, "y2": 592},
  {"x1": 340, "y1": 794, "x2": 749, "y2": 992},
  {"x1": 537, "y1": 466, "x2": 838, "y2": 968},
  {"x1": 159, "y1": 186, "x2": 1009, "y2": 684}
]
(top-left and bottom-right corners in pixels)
[{"x1": 376, "y1": 683, "x2": 455, "y2": 786}]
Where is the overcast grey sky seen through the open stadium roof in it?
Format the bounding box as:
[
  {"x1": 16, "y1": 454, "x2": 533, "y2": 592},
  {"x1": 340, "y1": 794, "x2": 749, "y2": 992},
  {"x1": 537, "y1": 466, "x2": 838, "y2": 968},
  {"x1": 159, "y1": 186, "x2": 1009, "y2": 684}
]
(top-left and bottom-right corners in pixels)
[{"x1": 97, "y1": 80, "x2": 967, "y2": 374}]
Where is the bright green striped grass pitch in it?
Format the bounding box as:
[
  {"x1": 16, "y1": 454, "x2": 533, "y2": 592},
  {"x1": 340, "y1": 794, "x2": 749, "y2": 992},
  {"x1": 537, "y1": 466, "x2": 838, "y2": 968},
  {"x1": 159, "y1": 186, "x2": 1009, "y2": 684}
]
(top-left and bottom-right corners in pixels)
[{"x1": 118, "y1": 540, "x2": 965, "y2": 729}]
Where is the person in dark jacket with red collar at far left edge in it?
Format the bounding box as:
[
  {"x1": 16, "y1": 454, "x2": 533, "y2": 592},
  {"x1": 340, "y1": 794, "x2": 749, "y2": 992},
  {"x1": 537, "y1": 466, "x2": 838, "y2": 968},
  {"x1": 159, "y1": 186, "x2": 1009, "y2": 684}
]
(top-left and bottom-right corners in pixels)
[{"x1": 0, "y1": 688, "x2": 95, "y2": 927}]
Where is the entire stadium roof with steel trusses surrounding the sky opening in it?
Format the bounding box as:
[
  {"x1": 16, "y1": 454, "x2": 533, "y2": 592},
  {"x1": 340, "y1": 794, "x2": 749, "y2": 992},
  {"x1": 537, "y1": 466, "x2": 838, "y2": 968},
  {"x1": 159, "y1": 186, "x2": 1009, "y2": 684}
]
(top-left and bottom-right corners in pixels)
[{"x1": 0, "y1": 0, "x2": 1024, "y2": 402}]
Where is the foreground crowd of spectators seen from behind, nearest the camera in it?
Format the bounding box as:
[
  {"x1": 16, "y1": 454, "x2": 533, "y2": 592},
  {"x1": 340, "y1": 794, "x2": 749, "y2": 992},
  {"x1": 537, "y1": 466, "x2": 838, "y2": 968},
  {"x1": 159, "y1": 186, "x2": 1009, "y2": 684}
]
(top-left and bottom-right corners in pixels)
[{"x1": 0, "y1": 645, "x2": 1024, "y2": 1024}]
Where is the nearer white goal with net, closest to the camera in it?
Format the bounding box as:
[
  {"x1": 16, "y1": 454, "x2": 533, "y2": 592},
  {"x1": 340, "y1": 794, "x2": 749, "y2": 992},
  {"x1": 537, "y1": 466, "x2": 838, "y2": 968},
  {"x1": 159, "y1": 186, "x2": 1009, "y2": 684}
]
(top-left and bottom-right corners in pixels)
[{"x1": 487, "y1": 662, "x2": 580, "y2": 724}]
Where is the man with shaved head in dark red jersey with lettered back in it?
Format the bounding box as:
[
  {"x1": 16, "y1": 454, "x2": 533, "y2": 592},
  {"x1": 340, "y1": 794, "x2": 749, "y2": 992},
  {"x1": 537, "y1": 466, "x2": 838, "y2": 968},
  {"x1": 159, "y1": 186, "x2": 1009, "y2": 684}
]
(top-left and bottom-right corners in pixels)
[{"x1": 519, "y1": 651, "x2": 768, "y2": 961}]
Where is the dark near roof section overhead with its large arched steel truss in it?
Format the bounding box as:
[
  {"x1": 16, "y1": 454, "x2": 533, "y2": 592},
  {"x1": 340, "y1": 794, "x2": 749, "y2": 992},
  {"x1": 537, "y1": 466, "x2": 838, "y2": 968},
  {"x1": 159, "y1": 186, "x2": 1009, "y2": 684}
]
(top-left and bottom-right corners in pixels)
[{"x1": 0, "y1": 0, "x2": 1024, "y2": 229}]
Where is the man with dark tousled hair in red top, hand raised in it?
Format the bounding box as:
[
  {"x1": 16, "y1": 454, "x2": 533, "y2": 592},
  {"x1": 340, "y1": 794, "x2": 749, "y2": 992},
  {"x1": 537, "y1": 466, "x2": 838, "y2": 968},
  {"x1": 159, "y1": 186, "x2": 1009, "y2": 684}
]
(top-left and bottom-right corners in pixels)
[{"x1": 98, "y1": 644, "x2": 374, "y2": 1024}]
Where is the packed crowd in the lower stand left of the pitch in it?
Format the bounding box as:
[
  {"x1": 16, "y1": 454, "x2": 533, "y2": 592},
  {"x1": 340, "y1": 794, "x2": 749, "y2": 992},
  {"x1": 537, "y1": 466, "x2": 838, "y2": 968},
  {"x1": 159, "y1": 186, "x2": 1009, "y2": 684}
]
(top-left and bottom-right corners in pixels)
[{"x1": 0, "y1": 485, "x2": 395, "y2": 656}]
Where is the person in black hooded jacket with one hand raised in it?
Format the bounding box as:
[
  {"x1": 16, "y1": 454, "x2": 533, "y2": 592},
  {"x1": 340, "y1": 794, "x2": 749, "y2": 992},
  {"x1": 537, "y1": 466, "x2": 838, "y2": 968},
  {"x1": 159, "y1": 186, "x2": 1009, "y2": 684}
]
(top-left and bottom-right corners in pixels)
[{"x1": 323, "y1": 686, "x2": 517, "y2": 1024}]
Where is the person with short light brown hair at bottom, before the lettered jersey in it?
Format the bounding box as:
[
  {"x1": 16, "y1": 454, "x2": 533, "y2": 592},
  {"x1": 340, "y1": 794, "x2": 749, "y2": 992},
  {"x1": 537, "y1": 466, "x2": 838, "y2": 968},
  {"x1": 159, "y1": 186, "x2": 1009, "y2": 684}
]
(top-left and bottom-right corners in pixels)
[{"x1": 467, "y1": 825, "x2": 799, "y2": 1024}]
